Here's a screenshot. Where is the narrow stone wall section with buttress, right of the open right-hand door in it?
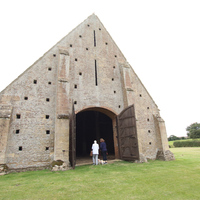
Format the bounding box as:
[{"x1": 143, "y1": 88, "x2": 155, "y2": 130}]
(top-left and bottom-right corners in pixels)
[{"x1": 123, "y1": 63, "x2": 167, "y2": 159}]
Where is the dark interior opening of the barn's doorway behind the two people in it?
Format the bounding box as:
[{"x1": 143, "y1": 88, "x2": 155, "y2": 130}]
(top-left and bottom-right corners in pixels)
[{"x1": 76, "y1": 111, "x2": 115, "y2": 157}]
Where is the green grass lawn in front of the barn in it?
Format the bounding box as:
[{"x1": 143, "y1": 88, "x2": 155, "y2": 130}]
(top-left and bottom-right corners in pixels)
[{"x1": 0, "y1": 148, "x2": 200, "y2": 200}]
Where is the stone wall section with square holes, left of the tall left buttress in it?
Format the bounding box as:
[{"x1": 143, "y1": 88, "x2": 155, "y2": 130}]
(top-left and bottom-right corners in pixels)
[{"x1": 0, "y1": 48, "x2": 57, "y2": 168}]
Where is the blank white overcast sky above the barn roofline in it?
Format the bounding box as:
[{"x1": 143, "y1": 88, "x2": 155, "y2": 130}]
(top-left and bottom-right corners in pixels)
[{"x1": 0, "y1": 0, "x2": 200, "y2": 136}]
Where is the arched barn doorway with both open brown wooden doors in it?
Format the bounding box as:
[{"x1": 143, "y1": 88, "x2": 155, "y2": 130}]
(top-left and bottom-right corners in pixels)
[{"x1": 69, "y1": 105, "x2": 139, "y2": 169}]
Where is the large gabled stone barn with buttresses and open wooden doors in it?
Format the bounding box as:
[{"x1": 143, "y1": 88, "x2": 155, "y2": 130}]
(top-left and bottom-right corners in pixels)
[{"x1": 0, "y1": 14, "x2": 173, "y2": 171}]
